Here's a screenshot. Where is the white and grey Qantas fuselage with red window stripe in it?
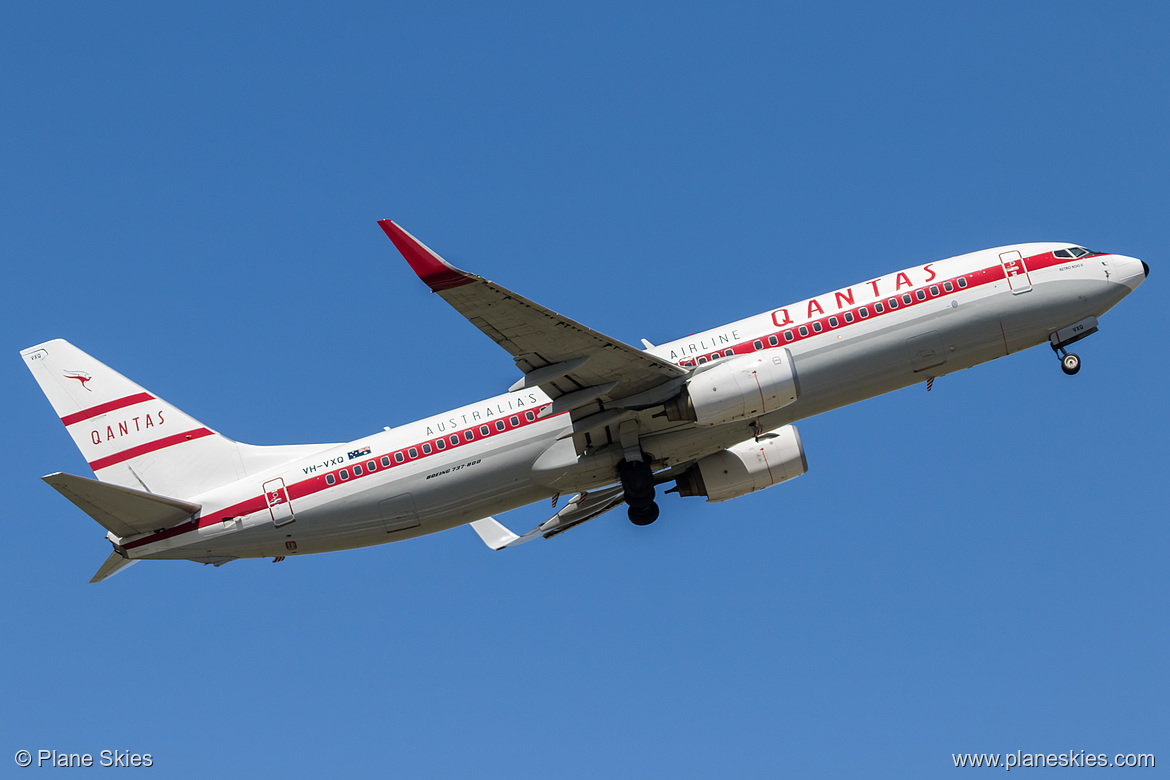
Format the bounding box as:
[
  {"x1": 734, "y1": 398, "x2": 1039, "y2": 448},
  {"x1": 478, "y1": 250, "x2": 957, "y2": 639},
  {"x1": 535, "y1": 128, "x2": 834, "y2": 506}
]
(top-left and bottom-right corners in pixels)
[{"x1": 124, "y1": 243, "x2": 1144, "y2": 562}]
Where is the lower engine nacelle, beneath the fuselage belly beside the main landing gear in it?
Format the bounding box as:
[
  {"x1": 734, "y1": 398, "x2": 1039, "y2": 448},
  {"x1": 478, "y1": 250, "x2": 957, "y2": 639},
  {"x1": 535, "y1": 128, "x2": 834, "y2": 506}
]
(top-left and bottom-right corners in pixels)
[{"x1": 677, "y1": 426, "x2": 808, "y2": 503}]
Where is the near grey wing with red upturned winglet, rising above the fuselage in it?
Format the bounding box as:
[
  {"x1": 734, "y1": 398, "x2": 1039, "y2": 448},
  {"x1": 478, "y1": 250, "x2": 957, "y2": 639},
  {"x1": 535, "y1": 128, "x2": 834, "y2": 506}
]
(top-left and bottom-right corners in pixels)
[{"x1": 378, "y1": 220, "x2": 687, "y2": 409}]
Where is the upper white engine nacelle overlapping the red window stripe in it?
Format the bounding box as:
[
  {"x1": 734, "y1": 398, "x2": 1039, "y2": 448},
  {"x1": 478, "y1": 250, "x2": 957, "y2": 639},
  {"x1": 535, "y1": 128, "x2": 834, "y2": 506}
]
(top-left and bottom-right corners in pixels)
[{"x1": 666, "y1": 347, "x2": 800, "y2": 426}]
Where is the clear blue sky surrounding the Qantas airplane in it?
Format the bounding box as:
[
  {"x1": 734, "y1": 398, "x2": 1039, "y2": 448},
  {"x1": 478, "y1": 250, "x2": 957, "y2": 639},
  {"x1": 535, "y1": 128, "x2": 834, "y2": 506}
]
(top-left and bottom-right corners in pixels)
[{"x1": 0, "y1": 2, "x2": 1170, "y2": 778}]
